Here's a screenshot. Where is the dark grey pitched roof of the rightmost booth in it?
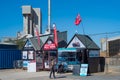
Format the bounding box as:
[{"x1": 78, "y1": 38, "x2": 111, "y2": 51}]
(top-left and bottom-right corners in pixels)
[{"x1": 68, "y1": 34, "x2": 100, "y2": 49}]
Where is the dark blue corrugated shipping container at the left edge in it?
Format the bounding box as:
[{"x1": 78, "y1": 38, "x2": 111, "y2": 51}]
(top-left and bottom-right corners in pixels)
[{"x1": 0, "y1": 49, "x2": 22, "y2": 69}]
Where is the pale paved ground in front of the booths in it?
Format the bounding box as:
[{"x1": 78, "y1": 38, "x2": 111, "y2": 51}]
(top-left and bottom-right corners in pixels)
[{"x1": 0, "y1": 69, "x2": 120, "y2": 80}]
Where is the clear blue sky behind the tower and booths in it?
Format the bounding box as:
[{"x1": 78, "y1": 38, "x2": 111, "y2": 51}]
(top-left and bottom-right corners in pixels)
[{"x1": 0, "y1": 0, "x2": 120, "y2": 44}]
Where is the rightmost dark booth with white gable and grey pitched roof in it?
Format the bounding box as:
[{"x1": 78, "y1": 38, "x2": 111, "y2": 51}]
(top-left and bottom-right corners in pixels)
[{"x1": 65, "y1": 34, "x2": 100, "y2": 73}]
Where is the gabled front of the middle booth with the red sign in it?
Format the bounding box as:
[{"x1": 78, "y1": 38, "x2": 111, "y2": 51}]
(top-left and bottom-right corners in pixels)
[{"x1": 43, "y1": 39, "x2": 58, "y2": 70}]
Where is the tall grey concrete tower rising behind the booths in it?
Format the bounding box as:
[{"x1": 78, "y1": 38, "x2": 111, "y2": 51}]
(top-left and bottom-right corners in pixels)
[{"x1": 22, "y1": 5, "x2": 42, "y2": 36}]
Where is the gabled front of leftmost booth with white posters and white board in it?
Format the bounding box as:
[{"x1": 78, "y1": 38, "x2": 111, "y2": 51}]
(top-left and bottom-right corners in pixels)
[{"x1": 22, "y1": 39, "x2": 37, "y2": 72}]
